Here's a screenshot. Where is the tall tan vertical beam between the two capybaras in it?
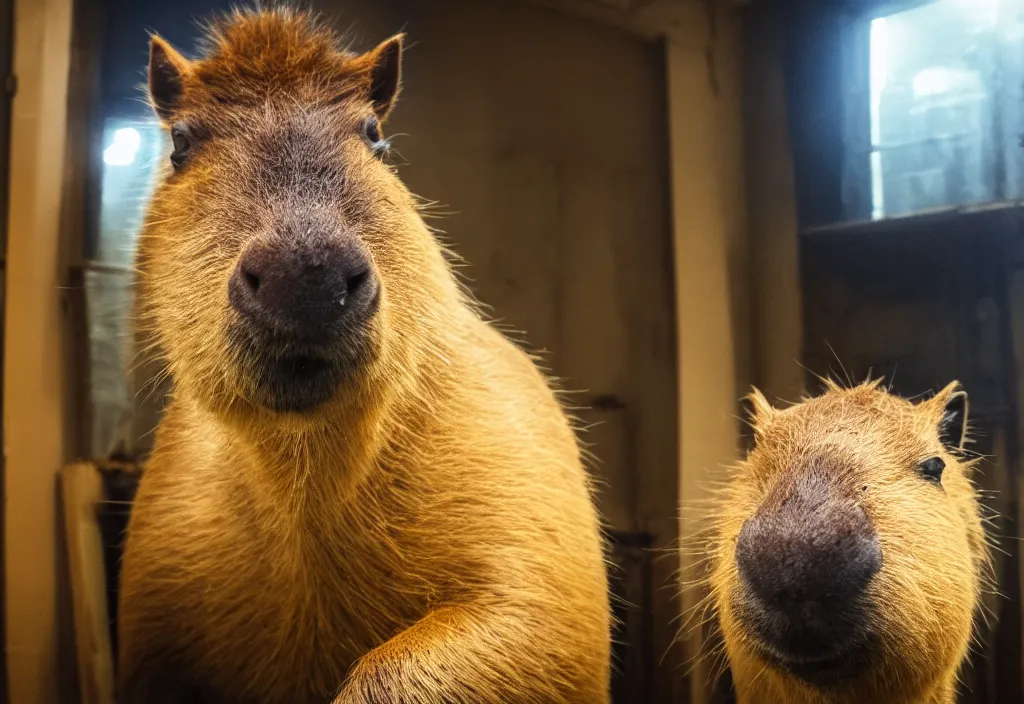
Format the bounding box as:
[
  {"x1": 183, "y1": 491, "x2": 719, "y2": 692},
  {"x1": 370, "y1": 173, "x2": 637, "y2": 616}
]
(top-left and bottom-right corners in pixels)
[{"x1": 666, "y1": 3, "x2": 751, "y2": 704}]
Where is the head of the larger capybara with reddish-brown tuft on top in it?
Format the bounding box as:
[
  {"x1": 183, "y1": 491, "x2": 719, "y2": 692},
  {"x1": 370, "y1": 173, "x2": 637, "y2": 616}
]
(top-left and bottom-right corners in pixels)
[{"x1": 138, "y1": 9, "x2": 457, "y2": 421}]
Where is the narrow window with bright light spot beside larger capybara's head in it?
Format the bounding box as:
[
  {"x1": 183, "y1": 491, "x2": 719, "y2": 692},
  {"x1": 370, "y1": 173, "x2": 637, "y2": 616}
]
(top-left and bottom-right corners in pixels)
[{"x1": 84, "y1": 0, "x2": 232, "y2": 455}]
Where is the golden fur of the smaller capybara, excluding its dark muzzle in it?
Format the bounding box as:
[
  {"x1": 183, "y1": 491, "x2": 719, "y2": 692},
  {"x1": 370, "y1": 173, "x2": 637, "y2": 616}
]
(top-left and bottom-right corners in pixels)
[{"x1": 696, "y1": 382, "x2": 990, "y2": 704}]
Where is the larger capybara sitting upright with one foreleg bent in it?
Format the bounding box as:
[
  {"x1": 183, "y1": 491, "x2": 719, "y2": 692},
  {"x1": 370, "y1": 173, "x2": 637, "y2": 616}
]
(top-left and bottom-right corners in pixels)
[{"x1": 119, "y1": 9, "x2": 609, "y2": 704}]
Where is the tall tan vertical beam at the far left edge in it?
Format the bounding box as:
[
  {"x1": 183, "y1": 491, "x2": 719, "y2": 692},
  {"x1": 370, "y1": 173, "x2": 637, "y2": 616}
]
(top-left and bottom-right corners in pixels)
[{"x1": 3, "y1": 0, "x2": 74, "y2": 704}]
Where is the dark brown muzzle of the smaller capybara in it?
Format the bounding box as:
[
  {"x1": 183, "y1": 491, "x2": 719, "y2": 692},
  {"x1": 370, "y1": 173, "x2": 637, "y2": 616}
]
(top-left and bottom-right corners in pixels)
[{"x1": 736, "y1": 477, "x2": 882, "y2": 658}]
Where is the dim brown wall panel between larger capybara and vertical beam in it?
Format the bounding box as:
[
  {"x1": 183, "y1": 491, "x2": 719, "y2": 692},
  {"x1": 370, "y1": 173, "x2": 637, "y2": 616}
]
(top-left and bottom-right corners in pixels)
[{"x1": 318, "y1": 0, "x2": 676, "y2": 544}]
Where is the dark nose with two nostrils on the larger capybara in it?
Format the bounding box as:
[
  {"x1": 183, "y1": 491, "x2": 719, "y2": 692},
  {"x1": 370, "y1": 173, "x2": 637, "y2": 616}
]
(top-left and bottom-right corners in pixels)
[{"x1": 228, "y1": 238, "x2": 379, "y2": 343}]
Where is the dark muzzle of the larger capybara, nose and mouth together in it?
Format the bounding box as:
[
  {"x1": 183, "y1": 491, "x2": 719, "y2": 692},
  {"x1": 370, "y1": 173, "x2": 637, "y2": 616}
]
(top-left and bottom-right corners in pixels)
[{"x1": 227, "y1": 231, "x2": 382, "y2": 412}]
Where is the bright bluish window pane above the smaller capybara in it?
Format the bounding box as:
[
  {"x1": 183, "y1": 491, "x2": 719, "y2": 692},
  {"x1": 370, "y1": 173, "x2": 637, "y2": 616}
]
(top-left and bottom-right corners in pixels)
[{"x1": 870, "y1": 0, "x2": 1024, "y2": 218}]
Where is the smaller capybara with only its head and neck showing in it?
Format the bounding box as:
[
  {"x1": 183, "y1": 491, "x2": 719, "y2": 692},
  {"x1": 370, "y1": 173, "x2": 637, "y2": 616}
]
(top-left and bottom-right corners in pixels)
[{"x1": 688, "y1": 382, "x2": 990, "y2": 704}]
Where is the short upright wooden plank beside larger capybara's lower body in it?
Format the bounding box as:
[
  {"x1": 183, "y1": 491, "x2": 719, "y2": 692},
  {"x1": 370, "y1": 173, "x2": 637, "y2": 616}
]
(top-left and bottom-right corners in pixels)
[{"x1": 60, "y1": 463, "x2": 114, "y2": 704}]
